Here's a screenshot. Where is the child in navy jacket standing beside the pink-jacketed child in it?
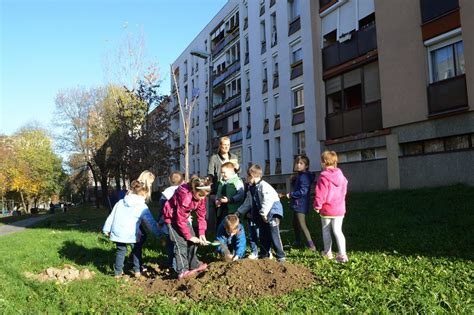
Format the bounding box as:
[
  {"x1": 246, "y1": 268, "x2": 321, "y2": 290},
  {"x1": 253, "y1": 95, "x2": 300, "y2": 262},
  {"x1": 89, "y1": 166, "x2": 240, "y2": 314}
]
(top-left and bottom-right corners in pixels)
[{"x1": 286, "y1": 155, "x2": 316, "y2": 251}]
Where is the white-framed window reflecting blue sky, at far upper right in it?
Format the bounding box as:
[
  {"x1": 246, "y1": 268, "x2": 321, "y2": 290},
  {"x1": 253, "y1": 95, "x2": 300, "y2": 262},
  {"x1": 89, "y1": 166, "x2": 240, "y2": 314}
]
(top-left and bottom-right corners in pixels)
[{"x1": 429, "y1": 40, "x2": 465, "y2": 82}]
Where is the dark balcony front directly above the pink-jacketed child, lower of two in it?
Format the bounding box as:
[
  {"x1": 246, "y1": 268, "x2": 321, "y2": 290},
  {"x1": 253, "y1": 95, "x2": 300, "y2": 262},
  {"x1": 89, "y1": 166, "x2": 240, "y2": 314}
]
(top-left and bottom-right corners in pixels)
[{"x1": 326, "y1": 101, "x2": 382, "y2": 139}]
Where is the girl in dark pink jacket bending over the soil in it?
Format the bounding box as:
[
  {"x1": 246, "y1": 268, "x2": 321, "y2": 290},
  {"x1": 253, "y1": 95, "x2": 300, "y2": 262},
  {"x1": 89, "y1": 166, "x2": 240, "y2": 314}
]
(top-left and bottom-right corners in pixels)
[{"x1": 163, "y1": 177, "x2": 211, "y2": 279}]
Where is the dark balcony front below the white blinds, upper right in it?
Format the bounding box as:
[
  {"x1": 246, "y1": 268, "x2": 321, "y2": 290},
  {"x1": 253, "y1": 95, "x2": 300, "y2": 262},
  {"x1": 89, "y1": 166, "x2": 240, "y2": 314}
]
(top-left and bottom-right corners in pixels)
[{"x1": 322, "y1": 23, "x2": 377, "y2": 71}]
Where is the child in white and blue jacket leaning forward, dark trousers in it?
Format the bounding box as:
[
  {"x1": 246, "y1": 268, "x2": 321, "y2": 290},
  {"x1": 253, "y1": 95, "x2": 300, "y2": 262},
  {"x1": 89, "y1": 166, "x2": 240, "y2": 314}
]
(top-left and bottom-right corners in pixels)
[{"x1": 237, "y1": 164, "x2": 285, "y2": 262}]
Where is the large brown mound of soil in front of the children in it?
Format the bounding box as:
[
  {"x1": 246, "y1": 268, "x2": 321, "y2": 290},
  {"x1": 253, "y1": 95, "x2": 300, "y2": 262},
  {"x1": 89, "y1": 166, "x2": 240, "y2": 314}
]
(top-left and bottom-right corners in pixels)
[{"x1": 139, "y1": 259, "x2": 316, "y2": 301}]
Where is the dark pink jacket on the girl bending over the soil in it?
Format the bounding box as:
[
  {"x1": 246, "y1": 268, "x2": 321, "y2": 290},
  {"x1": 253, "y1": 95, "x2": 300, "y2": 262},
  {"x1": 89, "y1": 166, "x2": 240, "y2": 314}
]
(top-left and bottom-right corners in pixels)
[{"x1": 163, "y1": 184, "x2": 207, "y2": 241}]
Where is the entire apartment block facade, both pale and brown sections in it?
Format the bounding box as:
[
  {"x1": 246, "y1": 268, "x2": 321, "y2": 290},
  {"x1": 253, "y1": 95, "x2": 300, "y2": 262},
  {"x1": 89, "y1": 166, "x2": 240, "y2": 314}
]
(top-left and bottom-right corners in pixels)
[{"x1": 171, "y1": 0, "x2": 474, "y2": 191}]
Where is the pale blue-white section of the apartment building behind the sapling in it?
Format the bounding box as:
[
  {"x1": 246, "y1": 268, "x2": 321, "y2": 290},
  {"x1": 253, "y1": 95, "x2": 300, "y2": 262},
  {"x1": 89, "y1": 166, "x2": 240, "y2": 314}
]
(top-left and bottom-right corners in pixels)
[{"x1": 171, "y1": 0, "x2": 320, "y2": 189}]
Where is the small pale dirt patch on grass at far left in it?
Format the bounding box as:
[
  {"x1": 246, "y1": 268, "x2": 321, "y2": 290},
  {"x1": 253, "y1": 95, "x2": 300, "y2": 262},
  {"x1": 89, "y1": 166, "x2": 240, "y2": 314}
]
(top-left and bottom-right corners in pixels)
[{"x1": 24, "y1": 265, "x2": 95, "y2": 283}]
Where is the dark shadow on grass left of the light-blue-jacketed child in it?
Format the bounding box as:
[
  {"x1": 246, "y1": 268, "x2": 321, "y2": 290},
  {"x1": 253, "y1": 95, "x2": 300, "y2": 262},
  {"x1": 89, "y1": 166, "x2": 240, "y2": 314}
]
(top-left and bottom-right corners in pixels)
[{"x1": 58, "y1": 241, "x2": 115, "y2": 273}]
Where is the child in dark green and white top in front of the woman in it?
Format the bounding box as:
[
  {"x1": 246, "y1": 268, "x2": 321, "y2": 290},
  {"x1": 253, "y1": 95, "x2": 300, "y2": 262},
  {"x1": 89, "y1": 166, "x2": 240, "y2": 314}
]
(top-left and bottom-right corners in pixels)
[{"x1": 216, "y1": 162, "x2": 244, "y2": 227}]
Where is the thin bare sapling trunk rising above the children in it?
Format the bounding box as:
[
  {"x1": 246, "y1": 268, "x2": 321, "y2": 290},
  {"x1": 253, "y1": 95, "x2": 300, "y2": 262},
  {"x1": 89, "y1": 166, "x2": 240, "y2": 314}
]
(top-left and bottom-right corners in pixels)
[{"x1": 171, "y1": 66, "x2": 197, "y2": 181}]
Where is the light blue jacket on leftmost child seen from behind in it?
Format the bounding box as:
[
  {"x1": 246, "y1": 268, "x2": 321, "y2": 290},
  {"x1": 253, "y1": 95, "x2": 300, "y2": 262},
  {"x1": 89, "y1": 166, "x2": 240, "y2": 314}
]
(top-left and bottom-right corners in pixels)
[{"x1": 102, "y1": 193, "x2": 159, "y2": 243}]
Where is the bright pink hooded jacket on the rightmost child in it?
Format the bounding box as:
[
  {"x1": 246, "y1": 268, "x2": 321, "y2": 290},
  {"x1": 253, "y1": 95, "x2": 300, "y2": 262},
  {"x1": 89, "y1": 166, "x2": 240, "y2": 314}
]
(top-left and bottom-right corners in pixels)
[{"x1": 313, "y1": 168, "x2": 347, "y2": 217}]
